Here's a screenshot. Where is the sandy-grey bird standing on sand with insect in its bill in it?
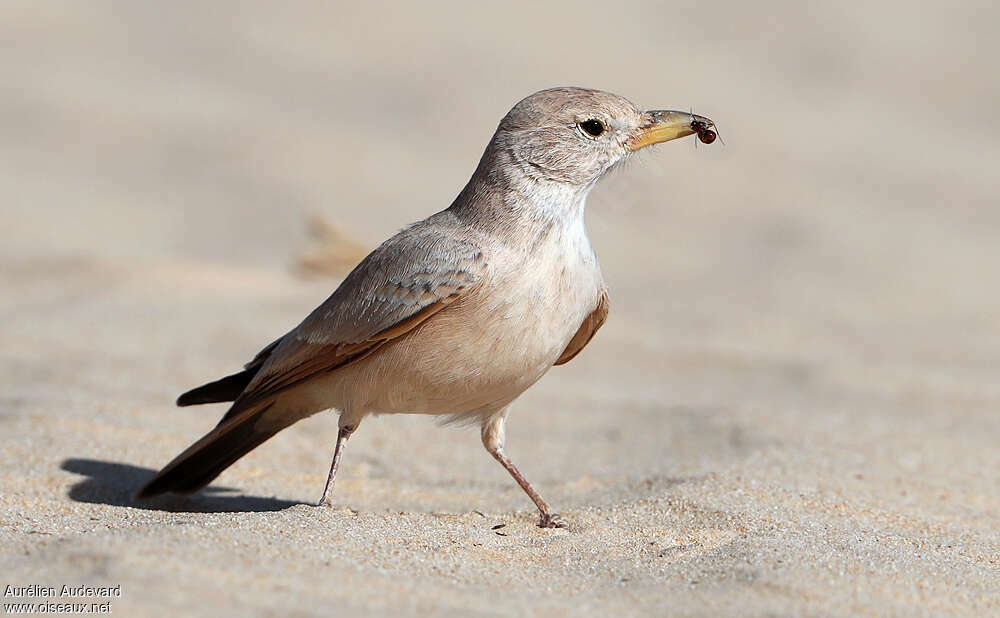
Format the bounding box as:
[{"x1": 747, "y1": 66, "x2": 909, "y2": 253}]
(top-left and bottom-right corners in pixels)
[{"x1": 137, "y1": 87, "x2": 715, "y2": 528}]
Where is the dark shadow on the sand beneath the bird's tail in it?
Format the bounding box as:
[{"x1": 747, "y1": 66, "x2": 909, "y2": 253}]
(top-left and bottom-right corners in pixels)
[{"x1": 59, "y1": 459, "x2": 302, "y2": 513}]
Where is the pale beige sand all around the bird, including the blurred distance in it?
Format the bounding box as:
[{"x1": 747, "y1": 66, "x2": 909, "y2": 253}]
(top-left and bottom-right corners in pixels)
[{"x1": 0, "y1": 1, "x2": 1000, "y2": 616}]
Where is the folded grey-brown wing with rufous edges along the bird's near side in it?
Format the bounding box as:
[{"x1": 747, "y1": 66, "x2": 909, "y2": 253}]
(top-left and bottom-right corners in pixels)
[{"x1": 223, "y1": 220, "x2": 486, "y2": 422}]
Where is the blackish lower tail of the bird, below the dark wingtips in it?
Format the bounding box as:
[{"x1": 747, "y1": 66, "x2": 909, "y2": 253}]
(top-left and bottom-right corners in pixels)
[{"x1": 136, "y1": 402, "x2": 287, "y2": 498}]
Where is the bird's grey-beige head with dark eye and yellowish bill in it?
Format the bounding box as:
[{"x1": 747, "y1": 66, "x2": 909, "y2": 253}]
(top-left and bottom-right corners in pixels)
[{"x1": 491, "y1": 88, "x2": 714, "y2": 188}]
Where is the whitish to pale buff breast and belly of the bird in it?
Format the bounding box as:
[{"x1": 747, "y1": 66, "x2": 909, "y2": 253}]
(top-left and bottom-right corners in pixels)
[{"x1": 324, "y1": 215, "x2": 603, "y2": 415}]
